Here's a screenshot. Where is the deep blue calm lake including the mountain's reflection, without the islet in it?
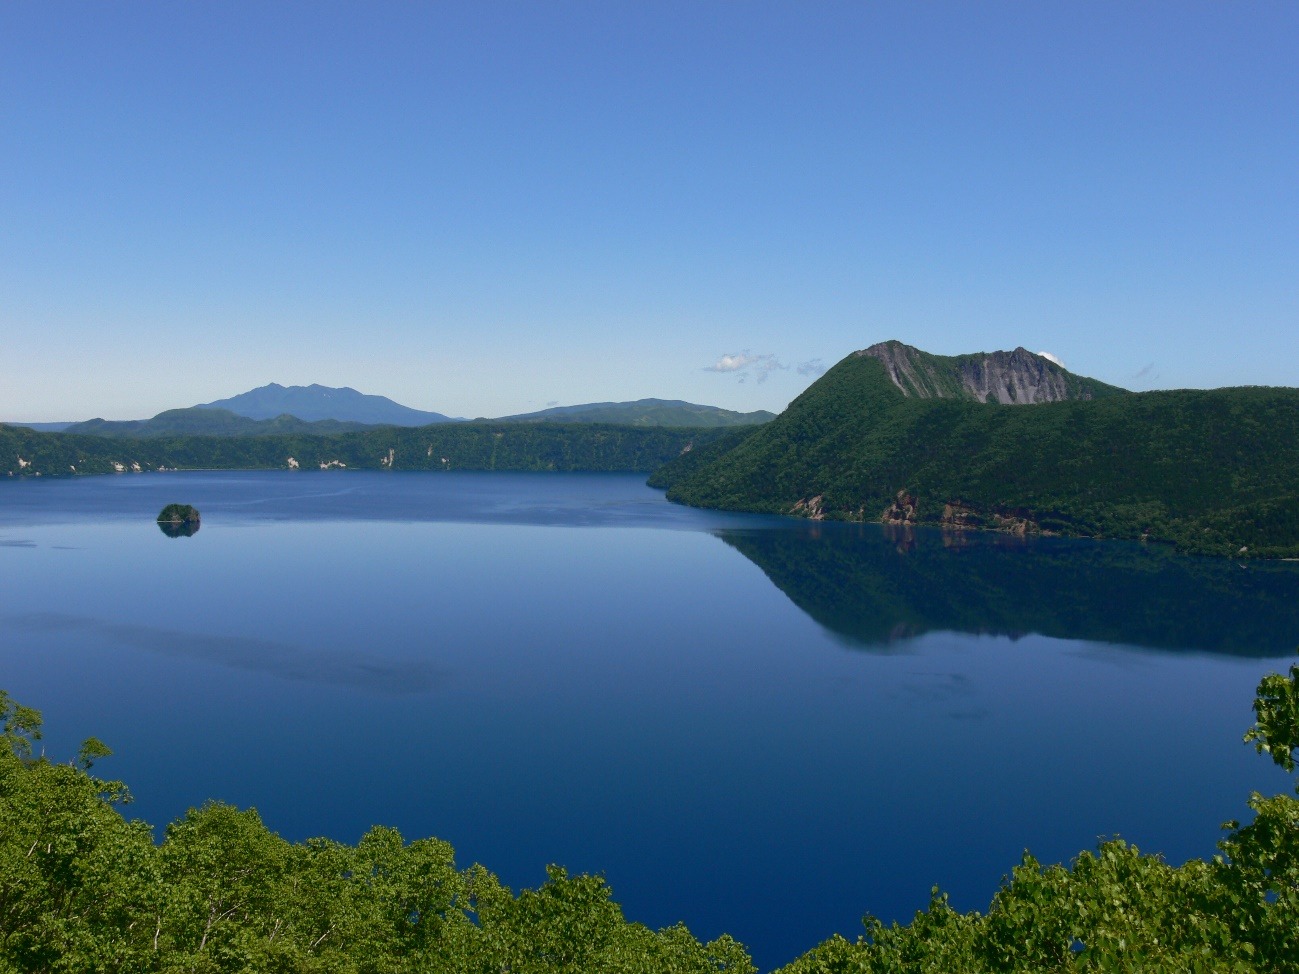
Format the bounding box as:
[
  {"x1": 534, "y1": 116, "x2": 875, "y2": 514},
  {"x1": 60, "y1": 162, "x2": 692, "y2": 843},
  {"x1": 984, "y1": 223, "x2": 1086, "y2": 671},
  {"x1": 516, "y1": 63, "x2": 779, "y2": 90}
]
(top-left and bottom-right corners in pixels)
[{"x1": 0, "y1": 471, "x2": 1299, "y2": 969}]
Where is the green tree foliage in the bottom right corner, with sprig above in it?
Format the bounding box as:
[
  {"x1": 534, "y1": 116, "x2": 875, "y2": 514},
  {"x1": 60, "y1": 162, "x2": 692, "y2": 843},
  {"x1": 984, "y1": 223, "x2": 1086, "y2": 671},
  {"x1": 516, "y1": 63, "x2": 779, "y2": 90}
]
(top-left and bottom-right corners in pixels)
[{"x1": 783, "y1": 666, "x2": 1299, "y2": 974}]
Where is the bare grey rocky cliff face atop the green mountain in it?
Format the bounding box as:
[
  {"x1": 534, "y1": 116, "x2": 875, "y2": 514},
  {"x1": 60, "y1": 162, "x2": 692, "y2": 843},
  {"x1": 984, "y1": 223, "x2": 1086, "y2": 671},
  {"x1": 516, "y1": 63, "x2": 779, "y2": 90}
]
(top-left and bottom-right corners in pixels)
[{"x1": 857, "y1": 342, "x2": 1120, "y2": 405}]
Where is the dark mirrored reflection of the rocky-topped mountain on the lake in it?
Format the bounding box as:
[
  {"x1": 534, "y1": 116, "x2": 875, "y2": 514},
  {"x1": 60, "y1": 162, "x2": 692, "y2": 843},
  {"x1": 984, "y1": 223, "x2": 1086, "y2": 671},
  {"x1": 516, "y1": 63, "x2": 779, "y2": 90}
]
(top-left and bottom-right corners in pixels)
[{"x1": 716, "y1": 523, "x2": 1299, "y2": 657}]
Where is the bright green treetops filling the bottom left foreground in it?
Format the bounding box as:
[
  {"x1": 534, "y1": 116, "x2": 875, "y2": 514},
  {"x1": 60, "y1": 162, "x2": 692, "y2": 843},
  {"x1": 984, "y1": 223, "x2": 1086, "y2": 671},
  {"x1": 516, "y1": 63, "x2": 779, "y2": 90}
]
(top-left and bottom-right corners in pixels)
[{"x1": 0, "y1": 693, "x2": 753, "y2": 974}]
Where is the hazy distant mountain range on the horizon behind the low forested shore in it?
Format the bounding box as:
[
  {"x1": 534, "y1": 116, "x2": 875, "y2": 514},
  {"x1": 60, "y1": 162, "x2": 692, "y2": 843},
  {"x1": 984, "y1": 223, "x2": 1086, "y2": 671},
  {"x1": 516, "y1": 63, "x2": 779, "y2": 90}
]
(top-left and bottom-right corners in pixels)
[{"x1": 12, "y1": 382, "x2": 776, "y2": 436}]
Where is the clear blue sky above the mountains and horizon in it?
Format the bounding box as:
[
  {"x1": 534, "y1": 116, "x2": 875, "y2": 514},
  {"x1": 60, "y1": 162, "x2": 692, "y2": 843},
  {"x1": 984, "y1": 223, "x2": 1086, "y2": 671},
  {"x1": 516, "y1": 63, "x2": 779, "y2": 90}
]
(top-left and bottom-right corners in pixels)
[{"x1": 0, "y1": 0, "x2": 1299, "y2": 421}]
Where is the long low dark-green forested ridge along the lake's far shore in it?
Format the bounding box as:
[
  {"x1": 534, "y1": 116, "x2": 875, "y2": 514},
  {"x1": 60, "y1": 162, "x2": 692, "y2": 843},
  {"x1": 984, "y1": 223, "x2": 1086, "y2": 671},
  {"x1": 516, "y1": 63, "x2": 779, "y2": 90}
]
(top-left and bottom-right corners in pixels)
[{"x1": 0, "y1": 423, "x2": 726, "y2": 477}]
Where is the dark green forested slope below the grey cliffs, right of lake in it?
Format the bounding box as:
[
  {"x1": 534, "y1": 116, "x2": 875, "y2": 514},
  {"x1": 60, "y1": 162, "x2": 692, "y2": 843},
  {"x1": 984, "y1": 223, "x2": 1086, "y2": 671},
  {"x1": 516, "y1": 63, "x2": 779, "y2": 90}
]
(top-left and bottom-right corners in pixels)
[{"x1": 655, "y1": 355, "x2": 1299, "y2": 556}]
